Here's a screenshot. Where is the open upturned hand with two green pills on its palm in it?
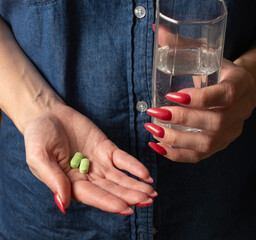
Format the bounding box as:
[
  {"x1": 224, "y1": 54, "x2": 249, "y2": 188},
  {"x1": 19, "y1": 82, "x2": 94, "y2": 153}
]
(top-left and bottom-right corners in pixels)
[{"x1": 24, "y1": 104, "x2": 156, "y2": 215}]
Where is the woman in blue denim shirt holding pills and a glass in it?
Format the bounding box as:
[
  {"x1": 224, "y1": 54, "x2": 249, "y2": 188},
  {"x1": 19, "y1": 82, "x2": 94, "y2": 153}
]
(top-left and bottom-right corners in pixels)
[{"x1": 0, "y1": 0, "x2": 256, "y2": 240}]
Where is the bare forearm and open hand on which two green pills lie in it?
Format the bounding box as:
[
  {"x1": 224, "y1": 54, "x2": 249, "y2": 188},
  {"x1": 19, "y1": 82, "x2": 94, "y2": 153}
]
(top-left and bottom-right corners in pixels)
[{"x1": 0, "y1": 18, "x2": 156, "y2": 215}]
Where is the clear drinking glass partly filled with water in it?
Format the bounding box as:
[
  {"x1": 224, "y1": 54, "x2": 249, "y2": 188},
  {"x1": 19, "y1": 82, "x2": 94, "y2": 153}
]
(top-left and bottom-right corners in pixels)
[{"x1": 152, "y1": 0, "x2": 227, "y2": 131}]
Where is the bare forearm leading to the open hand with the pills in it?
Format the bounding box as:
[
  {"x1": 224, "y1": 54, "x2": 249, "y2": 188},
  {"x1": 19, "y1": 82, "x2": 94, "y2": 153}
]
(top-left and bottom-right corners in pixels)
[{"x1": 0, "y1": 17, "x2": 62, "y2": 133}]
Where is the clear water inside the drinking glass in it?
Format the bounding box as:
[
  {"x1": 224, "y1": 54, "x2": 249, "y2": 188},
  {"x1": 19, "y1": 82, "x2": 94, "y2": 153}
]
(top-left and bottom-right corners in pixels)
[{"x1": 153, "y1": 47, "x2": 221, "y2": 131}]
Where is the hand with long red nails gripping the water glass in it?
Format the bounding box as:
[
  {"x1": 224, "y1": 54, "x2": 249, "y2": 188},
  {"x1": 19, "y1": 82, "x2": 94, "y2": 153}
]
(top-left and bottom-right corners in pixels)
[{"x1": 145, "y1": 60, "x2": 256, "y2": 163}]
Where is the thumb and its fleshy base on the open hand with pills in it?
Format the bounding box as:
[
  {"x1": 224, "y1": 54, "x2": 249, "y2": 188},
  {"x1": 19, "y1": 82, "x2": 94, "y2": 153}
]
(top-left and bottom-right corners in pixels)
[{"x1": 24, "y1": 114, "x2": 71, "y2": 213}]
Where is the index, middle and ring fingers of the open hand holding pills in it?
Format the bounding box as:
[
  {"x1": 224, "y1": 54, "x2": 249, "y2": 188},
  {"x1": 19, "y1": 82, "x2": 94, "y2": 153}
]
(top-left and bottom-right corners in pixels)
[{"x1": 67, "y1": 157, "x2": 157, "y2": 215}]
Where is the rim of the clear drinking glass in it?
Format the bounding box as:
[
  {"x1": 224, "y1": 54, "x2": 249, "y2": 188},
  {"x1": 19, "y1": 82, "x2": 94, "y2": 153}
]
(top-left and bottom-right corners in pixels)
[{"x1": 159, "y1": 0, "x2": 228, "y2": 24}]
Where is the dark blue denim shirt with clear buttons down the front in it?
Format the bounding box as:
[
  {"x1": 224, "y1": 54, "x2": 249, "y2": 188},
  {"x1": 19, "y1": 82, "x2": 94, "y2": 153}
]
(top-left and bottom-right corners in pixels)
[{"x1": 0, "y1": 0, "x2": 256, "y2": 240}]
